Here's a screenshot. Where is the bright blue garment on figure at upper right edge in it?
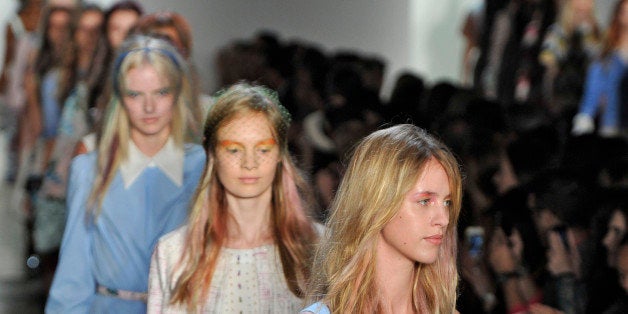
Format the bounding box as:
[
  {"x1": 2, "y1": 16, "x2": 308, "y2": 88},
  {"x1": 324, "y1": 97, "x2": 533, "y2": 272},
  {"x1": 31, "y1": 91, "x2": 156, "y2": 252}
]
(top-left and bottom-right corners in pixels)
[{"x1": 580, "y1": 52, "x2": 627, "y2": 128}]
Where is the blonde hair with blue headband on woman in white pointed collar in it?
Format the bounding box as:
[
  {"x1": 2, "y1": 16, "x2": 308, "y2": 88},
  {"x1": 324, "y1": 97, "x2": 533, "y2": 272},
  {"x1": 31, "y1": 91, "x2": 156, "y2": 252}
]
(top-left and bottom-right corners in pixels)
[{"x1": 88, "y1": 36, "x2": 201, "y2": 217}]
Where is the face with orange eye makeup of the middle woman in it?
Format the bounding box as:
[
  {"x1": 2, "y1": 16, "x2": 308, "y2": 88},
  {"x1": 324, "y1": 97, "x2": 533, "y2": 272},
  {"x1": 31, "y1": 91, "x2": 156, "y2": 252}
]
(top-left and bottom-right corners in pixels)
[{"x1": 215, "y1": 113, "x2": 281, "y2": 198}]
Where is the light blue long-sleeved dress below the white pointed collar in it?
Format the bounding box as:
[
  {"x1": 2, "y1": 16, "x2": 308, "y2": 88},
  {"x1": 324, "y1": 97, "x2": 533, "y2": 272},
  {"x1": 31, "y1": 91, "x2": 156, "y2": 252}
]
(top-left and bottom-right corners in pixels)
[{"x1": 46, "y1": 144, "x2": 205, "y2": 314}]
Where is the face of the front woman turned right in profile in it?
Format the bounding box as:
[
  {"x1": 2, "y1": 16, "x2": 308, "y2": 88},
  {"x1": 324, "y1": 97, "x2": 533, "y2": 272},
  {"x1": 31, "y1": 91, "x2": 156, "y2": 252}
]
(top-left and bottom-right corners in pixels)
[{"x1": 378, "y1": 158, "x2": 451, "y2": 264}]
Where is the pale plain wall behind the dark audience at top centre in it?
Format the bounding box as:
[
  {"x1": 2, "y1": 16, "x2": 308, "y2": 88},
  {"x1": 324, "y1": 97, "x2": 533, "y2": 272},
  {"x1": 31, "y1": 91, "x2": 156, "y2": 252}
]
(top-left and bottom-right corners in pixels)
[{"x1": 135, "y1": 0, "x2": 472, "y2": 97}]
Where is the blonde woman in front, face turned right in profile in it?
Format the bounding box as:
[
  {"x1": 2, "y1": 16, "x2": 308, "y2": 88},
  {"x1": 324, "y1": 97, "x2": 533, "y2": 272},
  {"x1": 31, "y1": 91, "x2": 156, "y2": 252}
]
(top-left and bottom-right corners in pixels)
[{"x1": 302, "y1": 124, "x2": 461, "y2": 314}]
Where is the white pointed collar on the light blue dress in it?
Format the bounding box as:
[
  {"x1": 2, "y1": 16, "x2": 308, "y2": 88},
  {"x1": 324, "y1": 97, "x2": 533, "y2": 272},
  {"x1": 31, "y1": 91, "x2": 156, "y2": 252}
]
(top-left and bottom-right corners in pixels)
[{"x1": 120, "y1": 138, "x2": 185, "y2": 189}]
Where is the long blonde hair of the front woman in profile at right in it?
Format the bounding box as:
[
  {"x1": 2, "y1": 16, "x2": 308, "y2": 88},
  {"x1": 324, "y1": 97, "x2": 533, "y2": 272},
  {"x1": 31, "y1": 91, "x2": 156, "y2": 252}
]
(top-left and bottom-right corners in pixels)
[{"x1": 308, "y1": 124, "x2": 462, "y2": 314}]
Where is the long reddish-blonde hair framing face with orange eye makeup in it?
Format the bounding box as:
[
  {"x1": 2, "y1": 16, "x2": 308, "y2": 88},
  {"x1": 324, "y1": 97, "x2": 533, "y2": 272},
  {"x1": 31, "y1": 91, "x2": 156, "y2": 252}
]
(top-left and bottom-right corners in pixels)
[{"x1": 170, "y1": 83, "x2": 317, "y2": 311}]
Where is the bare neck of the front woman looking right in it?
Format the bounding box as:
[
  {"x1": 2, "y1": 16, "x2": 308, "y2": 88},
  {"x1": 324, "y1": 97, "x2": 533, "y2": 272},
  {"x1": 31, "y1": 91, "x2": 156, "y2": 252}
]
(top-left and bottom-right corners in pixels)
[{"x1": 375, "y1": 237, "x2": 415, "y2": 313}]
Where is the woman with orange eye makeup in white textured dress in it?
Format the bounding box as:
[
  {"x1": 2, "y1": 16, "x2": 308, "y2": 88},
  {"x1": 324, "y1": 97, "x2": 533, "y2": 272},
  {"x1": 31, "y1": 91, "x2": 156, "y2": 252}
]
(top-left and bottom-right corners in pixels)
[{"x1": 148, "y1": 83, "x2": 318, "y2": 313}]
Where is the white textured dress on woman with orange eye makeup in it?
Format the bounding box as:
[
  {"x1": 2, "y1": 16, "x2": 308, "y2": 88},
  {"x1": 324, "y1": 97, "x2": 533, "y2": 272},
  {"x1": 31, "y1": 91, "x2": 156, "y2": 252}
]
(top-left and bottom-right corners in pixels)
[{"x1": 148, "y1": 227, "x2": 303, "y2": 314}]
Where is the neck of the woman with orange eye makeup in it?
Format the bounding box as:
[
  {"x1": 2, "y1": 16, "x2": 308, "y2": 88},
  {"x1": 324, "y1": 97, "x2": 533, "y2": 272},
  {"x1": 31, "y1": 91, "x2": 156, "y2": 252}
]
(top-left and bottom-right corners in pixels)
[{"x1": 225, "y1": 189, "x2": 274, "y2": 249}]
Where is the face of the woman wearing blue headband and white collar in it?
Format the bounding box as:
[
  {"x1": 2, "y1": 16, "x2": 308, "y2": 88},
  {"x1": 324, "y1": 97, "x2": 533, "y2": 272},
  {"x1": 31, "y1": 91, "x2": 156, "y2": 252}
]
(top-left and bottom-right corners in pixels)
[{"x1": 121, "y1": 64, "x2": 175, "y2": 143}]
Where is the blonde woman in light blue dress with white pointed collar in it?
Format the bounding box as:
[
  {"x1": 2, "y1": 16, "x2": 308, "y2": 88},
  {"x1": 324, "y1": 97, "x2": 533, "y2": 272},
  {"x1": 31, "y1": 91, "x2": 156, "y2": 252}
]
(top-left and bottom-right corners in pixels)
[{"x1": 46, "y1": 36, "x2": 205, "y2": 313}]
